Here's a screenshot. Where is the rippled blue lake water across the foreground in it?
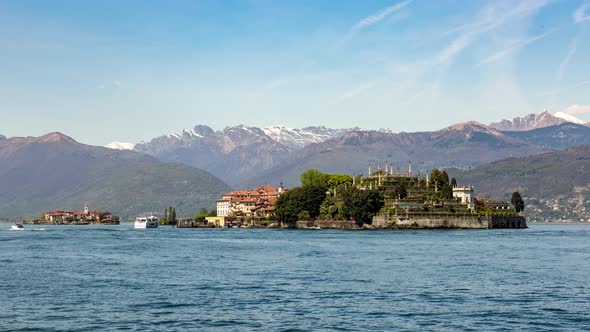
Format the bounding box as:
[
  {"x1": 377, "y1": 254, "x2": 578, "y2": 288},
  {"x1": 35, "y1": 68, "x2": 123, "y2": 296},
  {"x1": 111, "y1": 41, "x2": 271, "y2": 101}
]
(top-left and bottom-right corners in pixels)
[{"x1": 0, "y1": 224, "x2": 590, "y2": 331}]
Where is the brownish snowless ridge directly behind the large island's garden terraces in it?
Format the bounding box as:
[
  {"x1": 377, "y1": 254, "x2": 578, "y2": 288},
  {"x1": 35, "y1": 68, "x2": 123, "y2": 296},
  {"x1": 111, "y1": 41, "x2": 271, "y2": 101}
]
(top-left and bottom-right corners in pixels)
[{"x1": 247, "y1": 122, "x2": 556, "y2": 186}]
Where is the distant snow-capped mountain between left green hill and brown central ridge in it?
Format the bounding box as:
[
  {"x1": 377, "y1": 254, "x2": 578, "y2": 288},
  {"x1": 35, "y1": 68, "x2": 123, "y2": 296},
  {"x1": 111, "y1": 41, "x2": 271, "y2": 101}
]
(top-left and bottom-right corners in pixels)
[{"x1": 134, "y1": 125, "x2": 376, "y2": 185}]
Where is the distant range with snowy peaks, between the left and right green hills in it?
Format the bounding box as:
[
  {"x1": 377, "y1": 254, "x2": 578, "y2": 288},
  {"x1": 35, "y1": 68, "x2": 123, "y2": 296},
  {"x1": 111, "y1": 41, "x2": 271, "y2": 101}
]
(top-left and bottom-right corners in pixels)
[{"x1": 127, "y1": 112, "x2": 590, "y2": 187}]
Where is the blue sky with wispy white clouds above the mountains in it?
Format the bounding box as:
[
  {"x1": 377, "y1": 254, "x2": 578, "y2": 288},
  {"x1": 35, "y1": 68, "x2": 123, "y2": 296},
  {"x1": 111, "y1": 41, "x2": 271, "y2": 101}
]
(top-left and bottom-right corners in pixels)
[{"x1": 0, "y1": 0, "x2": 590, "y2": 145}]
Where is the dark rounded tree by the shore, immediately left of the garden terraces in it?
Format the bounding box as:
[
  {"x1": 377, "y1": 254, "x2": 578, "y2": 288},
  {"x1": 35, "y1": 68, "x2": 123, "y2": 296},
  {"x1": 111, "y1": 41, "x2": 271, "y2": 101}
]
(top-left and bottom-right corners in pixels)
[{"x1": 342, "y1": 188, "x2": 384, "y2": 225}]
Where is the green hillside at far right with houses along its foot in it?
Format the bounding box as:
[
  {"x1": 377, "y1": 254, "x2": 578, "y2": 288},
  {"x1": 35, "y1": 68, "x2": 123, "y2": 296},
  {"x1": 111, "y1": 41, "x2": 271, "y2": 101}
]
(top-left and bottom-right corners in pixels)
[{"x1": 449, "y1": 145, "x2": 590, "y2": 220}]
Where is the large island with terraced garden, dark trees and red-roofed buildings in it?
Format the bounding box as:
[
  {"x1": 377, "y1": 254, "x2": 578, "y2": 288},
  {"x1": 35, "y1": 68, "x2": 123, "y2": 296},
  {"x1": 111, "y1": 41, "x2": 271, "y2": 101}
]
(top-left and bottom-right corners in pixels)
[{"x1": 184, "y1": 162, "x2": 527, "y2": 229}]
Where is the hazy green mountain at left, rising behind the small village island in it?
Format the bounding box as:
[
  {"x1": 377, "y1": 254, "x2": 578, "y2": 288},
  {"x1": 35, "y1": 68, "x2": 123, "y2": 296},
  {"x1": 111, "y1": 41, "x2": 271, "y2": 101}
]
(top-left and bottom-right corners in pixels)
[{"x1": 0, "y1": 133, "x2": 229, "y2": 218}]
